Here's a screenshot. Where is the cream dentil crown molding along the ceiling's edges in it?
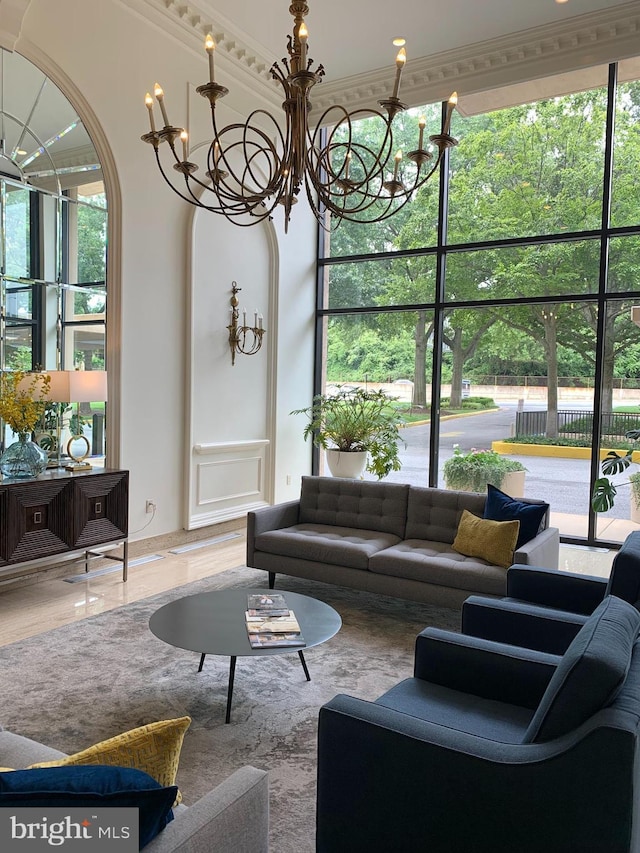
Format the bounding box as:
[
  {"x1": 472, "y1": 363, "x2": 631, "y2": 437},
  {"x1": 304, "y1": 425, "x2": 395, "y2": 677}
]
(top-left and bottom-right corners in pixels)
[{"x1": 129, "y1": 0, "x2": 640, "y2": 116}]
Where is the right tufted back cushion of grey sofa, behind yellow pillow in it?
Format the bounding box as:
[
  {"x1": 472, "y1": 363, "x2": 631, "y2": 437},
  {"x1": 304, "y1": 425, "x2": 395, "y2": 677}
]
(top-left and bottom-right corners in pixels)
[{"x1": 403, "y1": 486, "x2": 485, "y2": 545}]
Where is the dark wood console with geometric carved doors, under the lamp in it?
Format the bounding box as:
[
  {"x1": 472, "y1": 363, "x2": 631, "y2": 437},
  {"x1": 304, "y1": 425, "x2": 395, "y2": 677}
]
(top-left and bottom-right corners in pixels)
[{"x1": 0, "y1": 468, "x2": 129, "y2": 581}]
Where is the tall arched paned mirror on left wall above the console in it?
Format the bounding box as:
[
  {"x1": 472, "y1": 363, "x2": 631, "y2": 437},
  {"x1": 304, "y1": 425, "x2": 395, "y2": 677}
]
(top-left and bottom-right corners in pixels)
[{"x1": 0, "y1": 50, "x2": 107, "y2": 456}]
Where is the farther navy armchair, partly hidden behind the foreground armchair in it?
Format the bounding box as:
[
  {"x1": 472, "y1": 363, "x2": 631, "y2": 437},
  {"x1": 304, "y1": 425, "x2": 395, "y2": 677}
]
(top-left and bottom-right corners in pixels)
[{"x1": 462, "y1": 531, "x2": 640, "y2": 654}]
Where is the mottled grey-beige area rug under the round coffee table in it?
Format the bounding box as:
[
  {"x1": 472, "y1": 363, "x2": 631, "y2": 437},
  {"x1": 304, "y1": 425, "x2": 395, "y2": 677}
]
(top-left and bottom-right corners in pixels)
[{"x1": 0, "y1": 567, "x2": 459, "y2": 853}]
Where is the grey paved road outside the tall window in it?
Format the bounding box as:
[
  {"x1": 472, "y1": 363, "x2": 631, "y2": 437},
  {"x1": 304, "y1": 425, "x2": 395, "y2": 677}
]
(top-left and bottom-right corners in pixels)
[{"x1": 372, "y1": 405, "x2": 630, "y2": 519}]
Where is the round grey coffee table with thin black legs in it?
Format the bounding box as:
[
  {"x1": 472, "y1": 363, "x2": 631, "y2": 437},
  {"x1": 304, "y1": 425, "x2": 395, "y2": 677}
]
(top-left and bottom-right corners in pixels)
[{"x1": 149, "y1": 589, "x2": 342, "y2": 723}]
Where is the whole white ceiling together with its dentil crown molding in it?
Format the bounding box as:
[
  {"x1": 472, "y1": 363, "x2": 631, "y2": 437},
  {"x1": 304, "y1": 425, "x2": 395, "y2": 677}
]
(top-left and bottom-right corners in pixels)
[{"x1": 140, "y1": 0, "x2": 640, "y2": 123}]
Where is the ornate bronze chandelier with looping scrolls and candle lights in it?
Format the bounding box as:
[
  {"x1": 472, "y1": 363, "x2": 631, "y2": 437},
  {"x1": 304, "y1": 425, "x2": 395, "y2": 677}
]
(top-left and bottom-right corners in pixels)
[{"x1": 142, "y1": 0, "x2": 458, "y2": 232}]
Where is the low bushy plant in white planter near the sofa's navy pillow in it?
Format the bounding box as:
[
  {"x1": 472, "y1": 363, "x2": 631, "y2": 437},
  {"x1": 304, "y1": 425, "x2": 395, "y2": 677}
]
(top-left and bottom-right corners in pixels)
[{"x1": 443, "y1": 444, "x2": 527, "y2": 497}]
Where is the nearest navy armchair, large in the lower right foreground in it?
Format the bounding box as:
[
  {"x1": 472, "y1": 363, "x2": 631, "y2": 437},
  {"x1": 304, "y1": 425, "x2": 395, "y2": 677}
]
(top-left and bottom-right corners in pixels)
[{"x1": 316, "y1": 597, "x2": 640, "y2": 853}]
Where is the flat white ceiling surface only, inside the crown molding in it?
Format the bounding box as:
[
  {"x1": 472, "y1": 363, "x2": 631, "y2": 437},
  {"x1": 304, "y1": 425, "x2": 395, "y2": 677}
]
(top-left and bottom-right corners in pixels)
[{"x1": 199, "y1": 0, "x2": 629, "y2": 82}]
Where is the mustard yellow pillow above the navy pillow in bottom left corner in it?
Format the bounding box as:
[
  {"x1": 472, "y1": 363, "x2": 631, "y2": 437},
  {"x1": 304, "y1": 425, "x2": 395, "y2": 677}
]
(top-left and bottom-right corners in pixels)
[{"x1": 28, "y1": 717, "x2": 191, "y2": 802}]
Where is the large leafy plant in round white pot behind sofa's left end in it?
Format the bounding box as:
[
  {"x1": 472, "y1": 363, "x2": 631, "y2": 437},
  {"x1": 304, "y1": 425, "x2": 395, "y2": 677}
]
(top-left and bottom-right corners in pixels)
[{"x1": 291, "y1": 386, "x2": 403, "y2": 480}]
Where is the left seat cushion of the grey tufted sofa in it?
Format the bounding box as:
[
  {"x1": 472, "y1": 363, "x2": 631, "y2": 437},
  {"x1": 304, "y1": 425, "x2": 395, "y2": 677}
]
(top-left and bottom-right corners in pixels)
[{"x1": 256, "y1": 524, "x2": 400, "y2": 569}]
